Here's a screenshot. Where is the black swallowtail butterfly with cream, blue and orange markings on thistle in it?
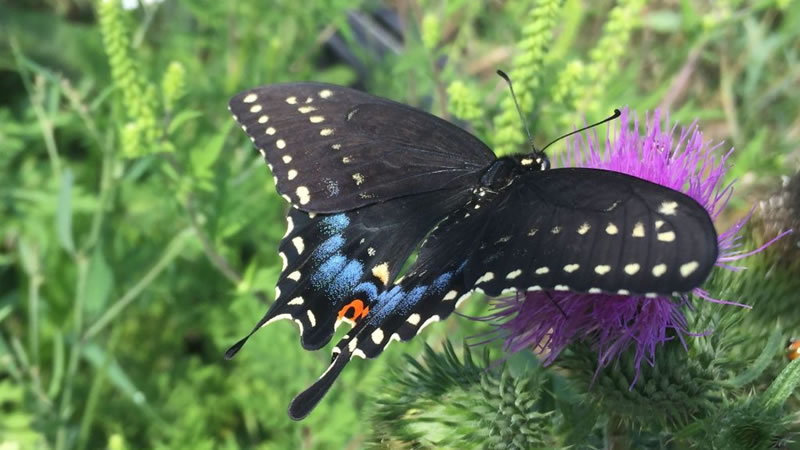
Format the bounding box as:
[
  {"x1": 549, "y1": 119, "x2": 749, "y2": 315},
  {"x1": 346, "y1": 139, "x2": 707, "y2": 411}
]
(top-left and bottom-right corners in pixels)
[{"x1": 226, "y1": 83, "x2": 718, "y2": 420}]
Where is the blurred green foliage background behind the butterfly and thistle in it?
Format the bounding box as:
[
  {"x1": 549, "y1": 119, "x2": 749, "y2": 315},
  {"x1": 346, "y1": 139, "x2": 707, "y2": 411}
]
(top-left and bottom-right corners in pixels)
[{"x1": 0, "y1": 0, "x2": 800, "y2": 449}]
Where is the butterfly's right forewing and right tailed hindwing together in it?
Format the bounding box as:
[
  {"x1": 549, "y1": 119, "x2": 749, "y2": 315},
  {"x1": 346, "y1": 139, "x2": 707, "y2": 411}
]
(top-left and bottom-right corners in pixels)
[{"x1": 289, "y1": 169, "x2": 717, "y2": 419}]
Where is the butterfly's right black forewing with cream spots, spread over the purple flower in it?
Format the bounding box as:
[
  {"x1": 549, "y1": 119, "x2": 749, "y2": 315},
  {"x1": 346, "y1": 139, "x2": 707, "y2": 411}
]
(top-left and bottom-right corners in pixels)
[{"x1": 466, "y1": 168, "x2": 718, "y2": 296}]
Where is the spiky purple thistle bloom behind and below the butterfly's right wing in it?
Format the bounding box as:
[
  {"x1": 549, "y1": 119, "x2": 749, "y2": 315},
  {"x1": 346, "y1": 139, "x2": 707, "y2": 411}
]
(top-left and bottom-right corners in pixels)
[{"x1": 485, "y1": 108, "x2": 790, "y2": 383}]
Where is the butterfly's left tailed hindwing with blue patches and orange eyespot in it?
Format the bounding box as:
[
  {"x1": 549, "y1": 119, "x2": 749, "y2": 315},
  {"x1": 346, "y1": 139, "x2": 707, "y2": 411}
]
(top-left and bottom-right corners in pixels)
[{"x1": 226, "y1": 186, "x2": 471, "y2": 358}]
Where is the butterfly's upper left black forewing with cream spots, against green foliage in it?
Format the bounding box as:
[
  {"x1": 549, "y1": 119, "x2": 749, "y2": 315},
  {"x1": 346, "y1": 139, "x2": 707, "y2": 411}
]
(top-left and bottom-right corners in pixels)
[{"x1": 229, "y1": 83, "x2": 495, "y2": 213}]
